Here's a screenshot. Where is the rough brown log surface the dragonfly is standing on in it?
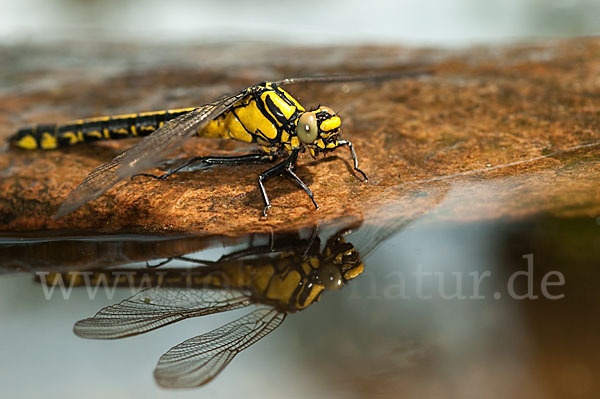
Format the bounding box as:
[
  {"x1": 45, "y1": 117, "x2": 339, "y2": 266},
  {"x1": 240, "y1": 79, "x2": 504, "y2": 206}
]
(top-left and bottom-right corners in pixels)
[{"x1": 0, "y1": 39, "x2": 600, "y2": 235}]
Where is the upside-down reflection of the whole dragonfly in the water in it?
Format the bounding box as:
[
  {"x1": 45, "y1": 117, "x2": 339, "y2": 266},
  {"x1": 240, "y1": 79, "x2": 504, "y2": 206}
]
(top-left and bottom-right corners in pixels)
[{"x1": 43, "y1": 214, "x2": 418, "y2": 388}]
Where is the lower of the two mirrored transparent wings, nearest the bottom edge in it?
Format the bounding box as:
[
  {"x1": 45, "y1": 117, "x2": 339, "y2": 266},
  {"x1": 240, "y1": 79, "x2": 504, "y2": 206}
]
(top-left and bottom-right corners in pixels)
[{"x1": 154, "y1": 308, "x2": 285, "y2": 388}]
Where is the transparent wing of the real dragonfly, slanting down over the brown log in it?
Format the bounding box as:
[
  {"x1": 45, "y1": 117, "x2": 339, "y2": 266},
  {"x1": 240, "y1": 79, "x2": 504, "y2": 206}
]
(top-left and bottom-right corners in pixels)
[{"x1": 54, "y1": 87, "x2": 252, "y2": 218}]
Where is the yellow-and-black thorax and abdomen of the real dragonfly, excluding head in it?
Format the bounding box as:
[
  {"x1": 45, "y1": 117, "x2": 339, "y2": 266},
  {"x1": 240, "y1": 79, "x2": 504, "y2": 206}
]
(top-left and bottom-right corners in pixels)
[{"x1": 10, "y1": 83, "x2": 304, "y2": 152}]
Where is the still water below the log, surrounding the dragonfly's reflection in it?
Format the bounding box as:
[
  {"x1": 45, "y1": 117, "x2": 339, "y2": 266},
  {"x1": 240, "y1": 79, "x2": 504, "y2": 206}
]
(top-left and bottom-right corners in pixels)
[{"x1": 0, "y1": 189, "x2": 600, "y2": 398}]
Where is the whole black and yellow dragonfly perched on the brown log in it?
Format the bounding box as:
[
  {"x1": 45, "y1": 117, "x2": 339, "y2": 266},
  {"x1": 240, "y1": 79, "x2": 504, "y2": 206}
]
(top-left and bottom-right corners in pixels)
[{"x1": 10, "y1": 70, "x2": 424, "y2": 217}]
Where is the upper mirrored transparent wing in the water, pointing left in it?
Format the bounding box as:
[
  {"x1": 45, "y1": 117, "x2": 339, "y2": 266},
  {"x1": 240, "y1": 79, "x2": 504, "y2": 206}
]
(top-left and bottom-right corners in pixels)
[{"x1": 73, "y1": 288, "x2": 251, "y2": 339}]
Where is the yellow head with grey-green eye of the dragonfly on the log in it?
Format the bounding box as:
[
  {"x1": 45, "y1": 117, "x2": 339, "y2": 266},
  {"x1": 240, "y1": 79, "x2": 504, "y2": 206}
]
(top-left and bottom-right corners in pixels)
[{"x1": 296, "y1": 107, "x2": 342, "y2": 157}]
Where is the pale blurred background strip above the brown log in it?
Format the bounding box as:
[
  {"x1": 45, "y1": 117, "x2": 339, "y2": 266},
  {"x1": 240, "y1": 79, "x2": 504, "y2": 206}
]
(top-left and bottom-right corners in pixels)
[{"x1": 0, "y1": 0, "x2": 600, "y2": 46}]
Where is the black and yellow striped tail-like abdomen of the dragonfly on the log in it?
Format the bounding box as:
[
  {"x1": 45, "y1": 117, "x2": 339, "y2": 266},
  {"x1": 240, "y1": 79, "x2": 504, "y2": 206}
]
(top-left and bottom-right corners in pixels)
[{"x1": 10, "y1": 108, "x2": 194, "y2": 150}]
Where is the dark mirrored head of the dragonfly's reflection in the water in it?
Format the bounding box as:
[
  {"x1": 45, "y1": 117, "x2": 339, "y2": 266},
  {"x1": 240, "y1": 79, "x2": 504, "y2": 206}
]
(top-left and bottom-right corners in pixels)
[{"x1": 317, "y1": 236, "x2": 364, "y2": 290}]
